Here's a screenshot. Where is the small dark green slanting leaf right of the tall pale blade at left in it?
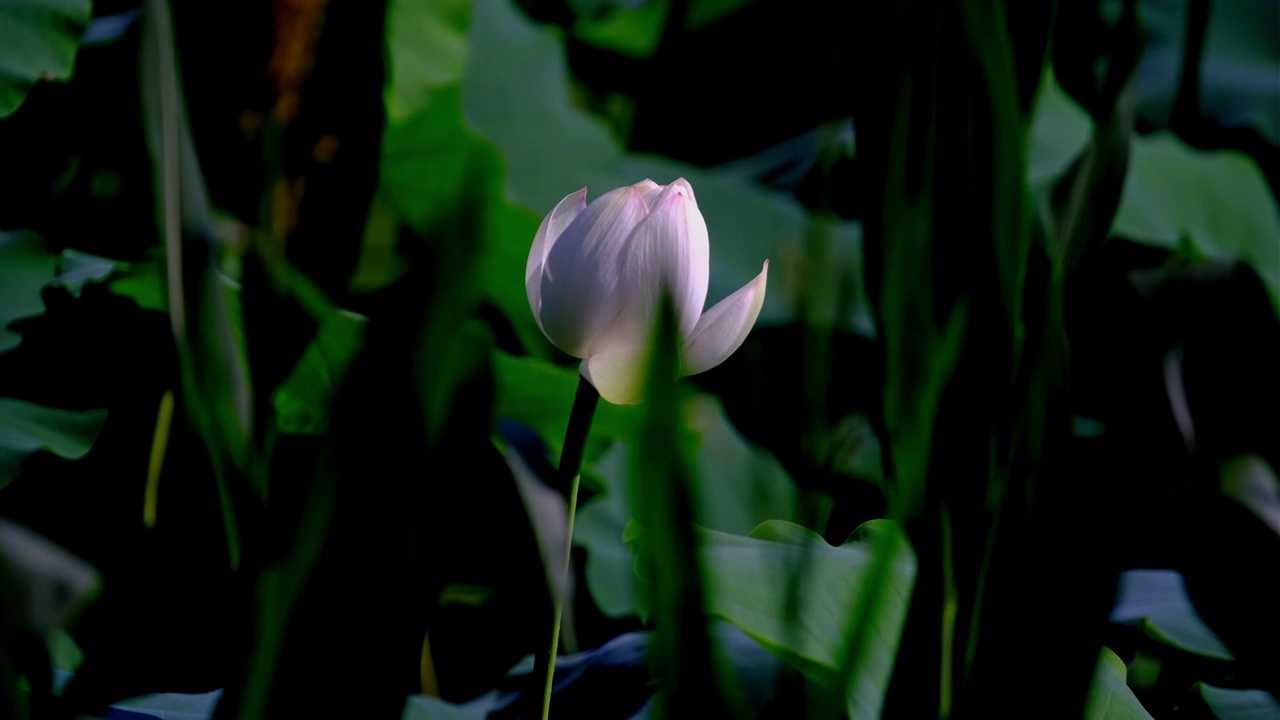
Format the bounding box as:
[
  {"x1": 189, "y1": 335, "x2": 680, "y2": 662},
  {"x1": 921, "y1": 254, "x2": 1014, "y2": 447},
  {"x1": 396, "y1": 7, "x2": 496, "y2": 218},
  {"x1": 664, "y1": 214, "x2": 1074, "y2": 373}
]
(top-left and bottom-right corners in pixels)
[{"x1": 271, "y1": 310, "x2": 369, "y2": 436}]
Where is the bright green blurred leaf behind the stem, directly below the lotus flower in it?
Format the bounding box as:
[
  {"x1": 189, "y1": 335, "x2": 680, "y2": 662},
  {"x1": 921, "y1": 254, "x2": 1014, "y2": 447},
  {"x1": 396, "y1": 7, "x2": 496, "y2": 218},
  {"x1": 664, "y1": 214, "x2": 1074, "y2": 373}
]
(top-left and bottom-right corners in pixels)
[{"x1": 493, "y1": 351, "x2": 639, "y2": 464}]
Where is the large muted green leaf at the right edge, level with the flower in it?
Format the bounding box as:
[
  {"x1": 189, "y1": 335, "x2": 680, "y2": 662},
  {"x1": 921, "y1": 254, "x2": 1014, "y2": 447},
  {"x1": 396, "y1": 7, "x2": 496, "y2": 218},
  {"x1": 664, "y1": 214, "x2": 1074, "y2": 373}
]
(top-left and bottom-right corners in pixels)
[{"x1": 1111, "y1": 132, "x2": 1280, "y2": 313}]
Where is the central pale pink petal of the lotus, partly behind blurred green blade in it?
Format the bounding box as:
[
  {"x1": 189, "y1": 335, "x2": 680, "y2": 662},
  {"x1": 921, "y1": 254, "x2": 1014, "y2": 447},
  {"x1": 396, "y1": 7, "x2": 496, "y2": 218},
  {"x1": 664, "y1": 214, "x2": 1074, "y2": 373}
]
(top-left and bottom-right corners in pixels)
[{"x1": 590, "y1": 184, "x2": 709, "y2": 355}]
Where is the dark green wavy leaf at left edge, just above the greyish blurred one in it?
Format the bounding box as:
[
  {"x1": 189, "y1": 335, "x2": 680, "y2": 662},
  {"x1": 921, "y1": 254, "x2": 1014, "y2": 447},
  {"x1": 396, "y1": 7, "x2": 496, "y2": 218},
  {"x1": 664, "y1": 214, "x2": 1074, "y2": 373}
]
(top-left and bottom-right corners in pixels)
[{"x1": 0, "y1": 397, "x2": 106, "y2": 488}]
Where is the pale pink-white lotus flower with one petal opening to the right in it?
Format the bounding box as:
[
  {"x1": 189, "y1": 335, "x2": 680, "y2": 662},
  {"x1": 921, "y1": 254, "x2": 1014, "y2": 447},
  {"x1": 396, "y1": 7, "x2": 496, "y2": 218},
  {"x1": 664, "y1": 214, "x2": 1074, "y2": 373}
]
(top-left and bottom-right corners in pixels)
[{"x1": 525, "y1": 178, "x2": 769, "y2": 405}]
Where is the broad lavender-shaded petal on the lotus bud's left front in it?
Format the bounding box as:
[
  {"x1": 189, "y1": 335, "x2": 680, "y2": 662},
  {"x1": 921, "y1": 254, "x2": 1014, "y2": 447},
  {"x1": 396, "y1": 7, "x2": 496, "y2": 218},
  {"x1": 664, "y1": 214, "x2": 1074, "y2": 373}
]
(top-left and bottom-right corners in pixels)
[{"x1": 539, "y1": 186, "x2": 648, "y2": 357}]
